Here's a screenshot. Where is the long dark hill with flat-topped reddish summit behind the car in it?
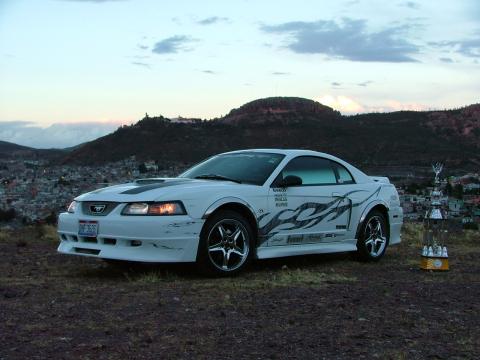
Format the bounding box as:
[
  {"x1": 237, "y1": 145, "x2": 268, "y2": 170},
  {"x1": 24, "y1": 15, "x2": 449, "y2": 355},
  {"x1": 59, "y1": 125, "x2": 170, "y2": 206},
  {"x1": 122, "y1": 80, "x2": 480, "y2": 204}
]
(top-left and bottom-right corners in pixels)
[{"x1": 63, "y1": 98, "x2": 480, "y2": 169}]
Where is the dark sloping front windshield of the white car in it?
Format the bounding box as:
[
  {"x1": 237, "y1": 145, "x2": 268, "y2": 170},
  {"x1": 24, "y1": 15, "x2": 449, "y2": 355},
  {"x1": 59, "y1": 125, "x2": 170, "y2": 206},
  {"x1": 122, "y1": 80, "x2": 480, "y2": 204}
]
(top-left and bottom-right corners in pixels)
[{"x1": 179, "y1": 152, "x2": 285, "y2": 185}]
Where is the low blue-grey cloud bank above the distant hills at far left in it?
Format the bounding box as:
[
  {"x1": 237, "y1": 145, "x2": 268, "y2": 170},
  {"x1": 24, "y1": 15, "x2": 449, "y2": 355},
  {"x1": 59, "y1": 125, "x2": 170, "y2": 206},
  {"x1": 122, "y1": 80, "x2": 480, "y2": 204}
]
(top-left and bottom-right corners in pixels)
[{"x1": 0, "y1": 121, "x2": 126, "y2": 149}]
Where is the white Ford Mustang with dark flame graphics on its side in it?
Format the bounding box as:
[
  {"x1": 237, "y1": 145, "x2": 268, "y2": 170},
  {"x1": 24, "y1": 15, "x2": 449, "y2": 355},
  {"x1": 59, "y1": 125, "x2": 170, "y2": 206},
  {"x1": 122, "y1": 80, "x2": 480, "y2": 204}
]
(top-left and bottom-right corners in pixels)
[{"x1": 58, "y1": 149, "x2": 403, "y2": 274}]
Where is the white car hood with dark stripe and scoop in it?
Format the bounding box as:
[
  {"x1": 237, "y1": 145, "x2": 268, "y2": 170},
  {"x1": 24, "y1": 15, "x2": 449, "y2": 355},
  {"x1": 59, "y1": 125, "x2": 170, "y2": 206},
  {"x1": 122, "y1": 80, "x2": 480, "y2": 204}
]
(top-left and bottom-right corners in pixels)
[{"x1": 75, "y1": 178, "x2": 256, "y2": 202}]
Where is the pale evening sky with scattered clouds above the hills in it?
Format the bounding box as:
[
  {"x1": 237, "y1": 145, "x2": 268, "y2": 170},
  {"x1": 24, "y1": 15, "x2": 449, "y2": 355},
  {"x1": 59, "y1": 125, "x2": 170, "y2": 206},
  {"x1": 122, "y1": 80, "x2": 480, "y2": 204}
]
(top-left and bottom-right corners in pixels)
[{"x1": 0, "y1": 0, "x2": 480, "y2": 148}]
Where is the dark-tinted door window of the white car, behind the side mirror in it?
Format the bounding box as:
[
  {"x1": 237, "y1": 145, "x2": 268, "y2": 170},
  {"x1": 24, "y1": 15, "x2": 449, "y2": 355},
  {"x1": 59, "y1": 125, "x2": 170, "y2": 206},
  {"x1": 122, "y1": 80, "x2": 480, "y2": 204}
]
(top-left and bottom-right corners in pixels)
[{"x1": 280, "y1": 156, "x2": 337, "y2": 185}]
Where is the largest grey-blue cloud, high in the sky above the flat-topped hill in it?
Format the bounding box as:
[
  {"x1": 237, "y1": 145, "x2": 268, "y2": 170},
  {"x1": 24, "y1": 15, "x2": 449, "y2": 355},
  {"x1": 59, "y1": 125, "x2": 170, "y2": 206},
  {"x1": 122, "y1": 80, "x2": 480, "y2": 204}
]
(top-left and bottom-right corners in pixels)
[{"x1": 261, "y1": 18, "x2": 419, "y2": 62}]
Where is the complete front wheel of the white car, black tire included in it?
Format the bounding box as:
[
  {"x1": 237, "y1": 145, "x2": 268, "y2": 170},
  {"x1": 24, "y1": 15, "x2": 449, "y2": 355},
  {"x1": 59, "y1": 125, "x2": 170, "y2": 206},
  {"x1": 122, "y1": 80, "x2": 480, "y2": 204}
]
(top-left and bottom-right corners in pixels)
[{"x1": 197, "y1": 210, "x2": 255, "y2": 276}]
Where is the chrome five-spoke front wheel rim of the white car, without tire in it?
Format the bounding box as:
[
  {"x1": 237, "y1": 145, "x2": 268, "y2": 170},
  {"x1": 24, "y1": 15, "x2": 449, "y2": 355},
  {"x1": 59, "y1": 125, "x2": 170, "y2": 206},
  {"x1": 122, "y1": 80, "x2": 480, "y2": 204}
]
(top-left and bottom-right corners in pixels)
[{"x1": 207, "y1": 219, "x2": 250, "y2": 272}]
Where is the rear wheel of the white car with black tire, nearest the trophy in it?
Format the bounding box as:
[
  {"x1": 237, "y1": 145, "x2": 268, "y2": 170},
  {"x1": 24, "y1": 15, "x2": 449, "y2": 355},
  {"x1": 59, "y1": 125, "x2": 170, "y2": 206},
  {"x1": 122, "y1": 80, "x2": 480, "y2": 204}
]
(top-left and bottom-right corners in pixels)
[{"x1": 357, "y1": 210, "x2": 389, "y2": 261}]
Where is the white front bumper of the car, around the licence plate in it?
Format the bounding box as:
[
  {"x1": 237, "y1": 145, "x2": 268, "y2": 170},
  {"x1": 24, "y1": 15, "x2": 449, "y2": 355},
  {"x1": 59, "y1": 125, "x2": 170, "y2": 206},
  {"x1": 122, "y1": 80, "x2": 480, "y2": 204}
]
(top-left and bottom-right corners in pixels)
[{"x1": 57, "y1": 206, "x2": 204, "y2": 263}]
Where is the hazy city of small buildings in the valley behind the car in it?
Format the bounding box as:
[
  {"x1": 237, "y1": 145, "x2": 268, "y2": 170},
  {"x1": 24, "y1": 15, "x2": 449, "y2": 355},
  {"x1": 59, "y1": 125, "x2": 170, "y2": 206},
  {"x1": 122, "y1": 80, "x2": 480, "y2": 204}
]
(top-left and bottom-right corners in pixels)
[{"x1": 0, "y1": 156, "x2": 480, "y2": 229}]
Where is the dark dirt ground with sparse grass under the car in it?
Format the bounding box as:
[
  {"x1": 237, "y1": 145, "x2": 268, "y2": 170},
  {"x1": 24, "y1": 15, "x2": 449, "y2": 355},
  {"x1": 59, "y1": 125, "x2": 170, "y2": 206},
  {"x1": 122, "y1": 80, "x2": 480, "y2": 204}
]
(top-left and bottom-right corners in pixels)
[{"x1": 0, "y1": 225, "x2": 480, "y2": 359}]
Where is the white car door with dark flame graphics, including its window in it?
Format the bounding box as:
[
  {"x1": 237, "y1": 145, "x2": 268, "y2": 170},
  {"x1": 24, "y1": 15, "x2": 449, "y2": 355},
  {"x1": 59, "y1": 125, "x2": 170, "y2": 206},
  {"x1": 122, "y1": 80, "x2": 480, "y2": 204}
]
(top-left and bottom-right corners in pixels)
[{"x1": 260, "y1": 156, "x2": 352, "y2": 246}]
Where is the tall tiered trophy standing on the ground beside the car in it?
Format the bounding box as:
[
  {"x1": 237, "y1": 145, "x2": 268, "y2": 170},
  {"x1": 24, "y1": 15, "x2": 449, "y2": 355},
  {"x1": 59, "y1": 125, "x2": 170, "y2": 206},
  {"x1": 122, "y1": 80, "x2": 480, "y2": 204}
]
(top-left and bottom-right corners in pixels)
[{"x1": 420, "y1": 163, "x2": 449, "y2": 271}]
